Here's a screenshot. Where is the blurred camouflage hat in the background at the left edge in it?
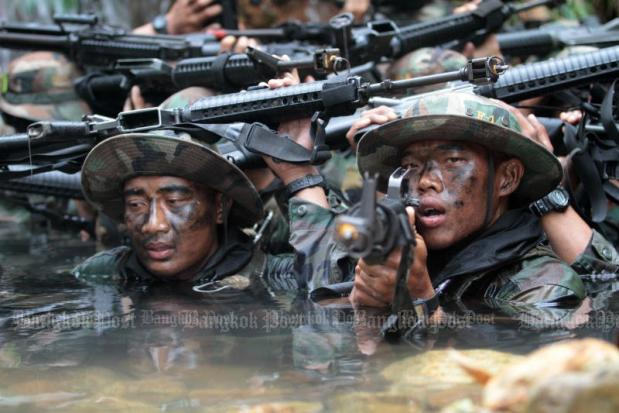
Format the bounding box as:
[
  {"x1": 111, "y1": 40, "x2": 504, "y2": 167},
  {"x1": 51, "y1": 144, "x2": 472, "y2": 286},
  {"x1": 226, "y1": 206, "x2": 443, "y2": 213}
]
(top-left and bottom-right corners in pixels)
[{"x1": 0, "y1": 52, "x2": 90, "y2": 121}]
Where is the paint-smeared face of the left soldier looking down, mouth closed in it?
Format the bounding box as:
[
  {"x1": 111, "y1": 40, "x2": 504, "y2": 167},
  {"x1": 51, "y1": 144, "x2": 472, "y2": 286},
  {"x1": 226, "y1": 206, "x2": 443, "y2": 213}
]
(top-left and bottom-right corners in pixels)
[{"x1": 124, "y1": 176, "x2": 221, "y2": 280}]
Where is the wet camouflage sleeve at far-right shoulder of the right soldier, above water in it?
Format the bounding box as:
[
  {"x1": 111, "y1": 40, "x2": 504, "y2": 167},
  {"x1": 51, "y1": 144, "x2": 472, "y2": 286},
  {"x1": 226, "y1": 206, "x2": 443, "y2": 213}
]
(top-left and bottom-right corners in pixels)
[{"x1": 493, "y1": 251, "x2": 586, "y2": 306}]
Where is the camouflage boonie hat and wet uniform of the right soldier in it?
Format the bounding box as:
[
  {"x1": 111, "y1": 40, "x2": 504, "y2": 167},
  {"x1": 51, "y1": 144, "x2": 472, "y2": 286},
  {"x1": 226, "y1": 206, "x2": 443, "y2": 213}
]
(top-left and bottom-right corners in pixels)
[{"x1": 290, "y1": 93, "x2": 616, "y2": 306}]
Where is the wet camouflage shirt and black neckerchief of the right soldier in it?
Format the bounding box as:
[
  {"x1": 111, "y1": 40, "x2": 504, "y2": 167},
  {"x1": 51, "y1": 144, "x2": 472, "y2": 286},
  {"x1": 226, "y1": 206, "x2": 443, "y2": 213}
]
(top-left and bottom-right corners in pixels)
[{"x1": 290, "y1": 199, "x2": 586, "y2": 304}]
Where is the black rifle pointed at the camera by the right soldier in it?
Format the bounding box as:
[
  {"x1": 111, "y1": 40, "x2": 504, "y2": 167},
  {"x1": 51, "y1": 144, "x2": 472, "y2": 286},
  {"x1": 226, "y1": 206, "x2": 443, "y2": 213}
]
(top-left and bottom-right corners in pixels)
[{"x1": 335, "y1": 167, "x2": 427, "y2": 338}]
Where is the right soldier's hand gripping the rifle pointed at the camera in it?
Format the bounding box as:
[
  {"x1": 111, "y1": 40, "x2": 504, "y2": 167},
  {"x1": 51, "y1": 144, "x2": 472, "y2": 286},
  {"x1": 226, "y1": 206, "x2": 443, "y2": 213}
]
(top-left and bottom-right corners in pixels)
[{"x1": 350, "y1": 207, "x2": 434, "y2": 307}]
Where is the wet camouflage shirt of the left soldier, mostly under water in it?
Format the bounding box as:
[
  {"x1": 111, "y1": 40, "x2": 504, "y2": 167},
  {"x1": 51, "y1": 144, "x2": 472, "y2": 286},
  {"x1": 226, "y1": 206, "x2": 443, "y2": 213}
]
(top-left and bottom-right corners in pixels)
[{"x1": 72, "y1": 230, "x2": 300, "y2": 292}]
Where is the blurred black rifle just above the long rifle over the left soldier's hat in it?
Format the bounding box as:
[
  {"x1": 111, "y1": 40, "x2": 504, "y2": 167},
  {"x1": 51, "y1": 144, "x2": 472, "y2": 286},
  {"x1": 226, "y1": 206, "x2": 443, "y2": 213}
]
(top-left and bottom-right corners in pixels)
[{"x1": 75, "y1": 48, "x2": 346, "y2": 116}]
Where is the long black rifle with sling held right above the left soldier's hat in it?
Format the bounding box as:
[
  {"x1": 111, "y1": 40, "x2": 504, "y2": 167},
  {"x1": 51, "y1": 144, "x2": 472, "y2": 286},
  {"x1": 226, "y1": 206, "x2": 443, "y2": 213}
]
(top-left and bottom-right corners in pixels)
[{"x1": 0, "y1": 57, "x2": 506, "y2": 175}]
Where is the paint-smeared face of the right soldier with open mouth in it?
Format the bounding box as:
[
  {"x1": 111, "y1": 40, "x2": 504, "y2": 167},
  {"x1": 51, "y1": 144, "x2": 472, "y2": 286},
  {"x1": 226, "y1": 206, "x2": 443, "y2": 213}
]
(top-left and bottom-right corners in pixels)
[{"x1": 401, "y1": 140, "x2": 488, "y2": 250}]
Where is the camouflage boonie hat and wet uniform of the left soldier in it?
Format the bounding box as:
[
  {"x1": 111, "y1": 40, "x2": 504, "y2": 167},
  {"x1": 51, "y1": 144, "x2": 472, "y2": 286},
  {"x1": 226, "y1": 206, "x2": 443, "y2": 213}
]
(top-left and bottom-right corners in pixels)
[{"x1": 73, "y1": 131, "x2": 303, "y2": 292}]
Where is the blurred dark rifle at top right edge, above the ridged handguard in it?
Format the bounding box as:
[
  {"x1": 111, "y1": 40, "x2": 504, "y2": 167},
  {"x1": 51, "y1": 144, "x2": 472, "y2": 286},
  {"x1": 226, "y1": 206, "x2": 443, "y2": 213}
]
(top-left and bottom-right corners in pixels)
[{"x1": 497, "y1": 18, "x2": 619, "y2": 57}]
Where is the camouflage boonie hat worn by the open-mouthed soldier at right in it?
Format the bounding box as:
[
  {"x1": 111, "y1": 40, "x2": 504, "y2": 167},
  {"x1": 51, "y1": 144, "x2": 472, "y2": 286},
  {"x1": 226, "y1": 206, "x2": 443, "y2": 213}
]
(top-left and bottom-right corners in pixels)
[{"x1": 357, "y1": 92, "x2": 563, "y2": 203}]
